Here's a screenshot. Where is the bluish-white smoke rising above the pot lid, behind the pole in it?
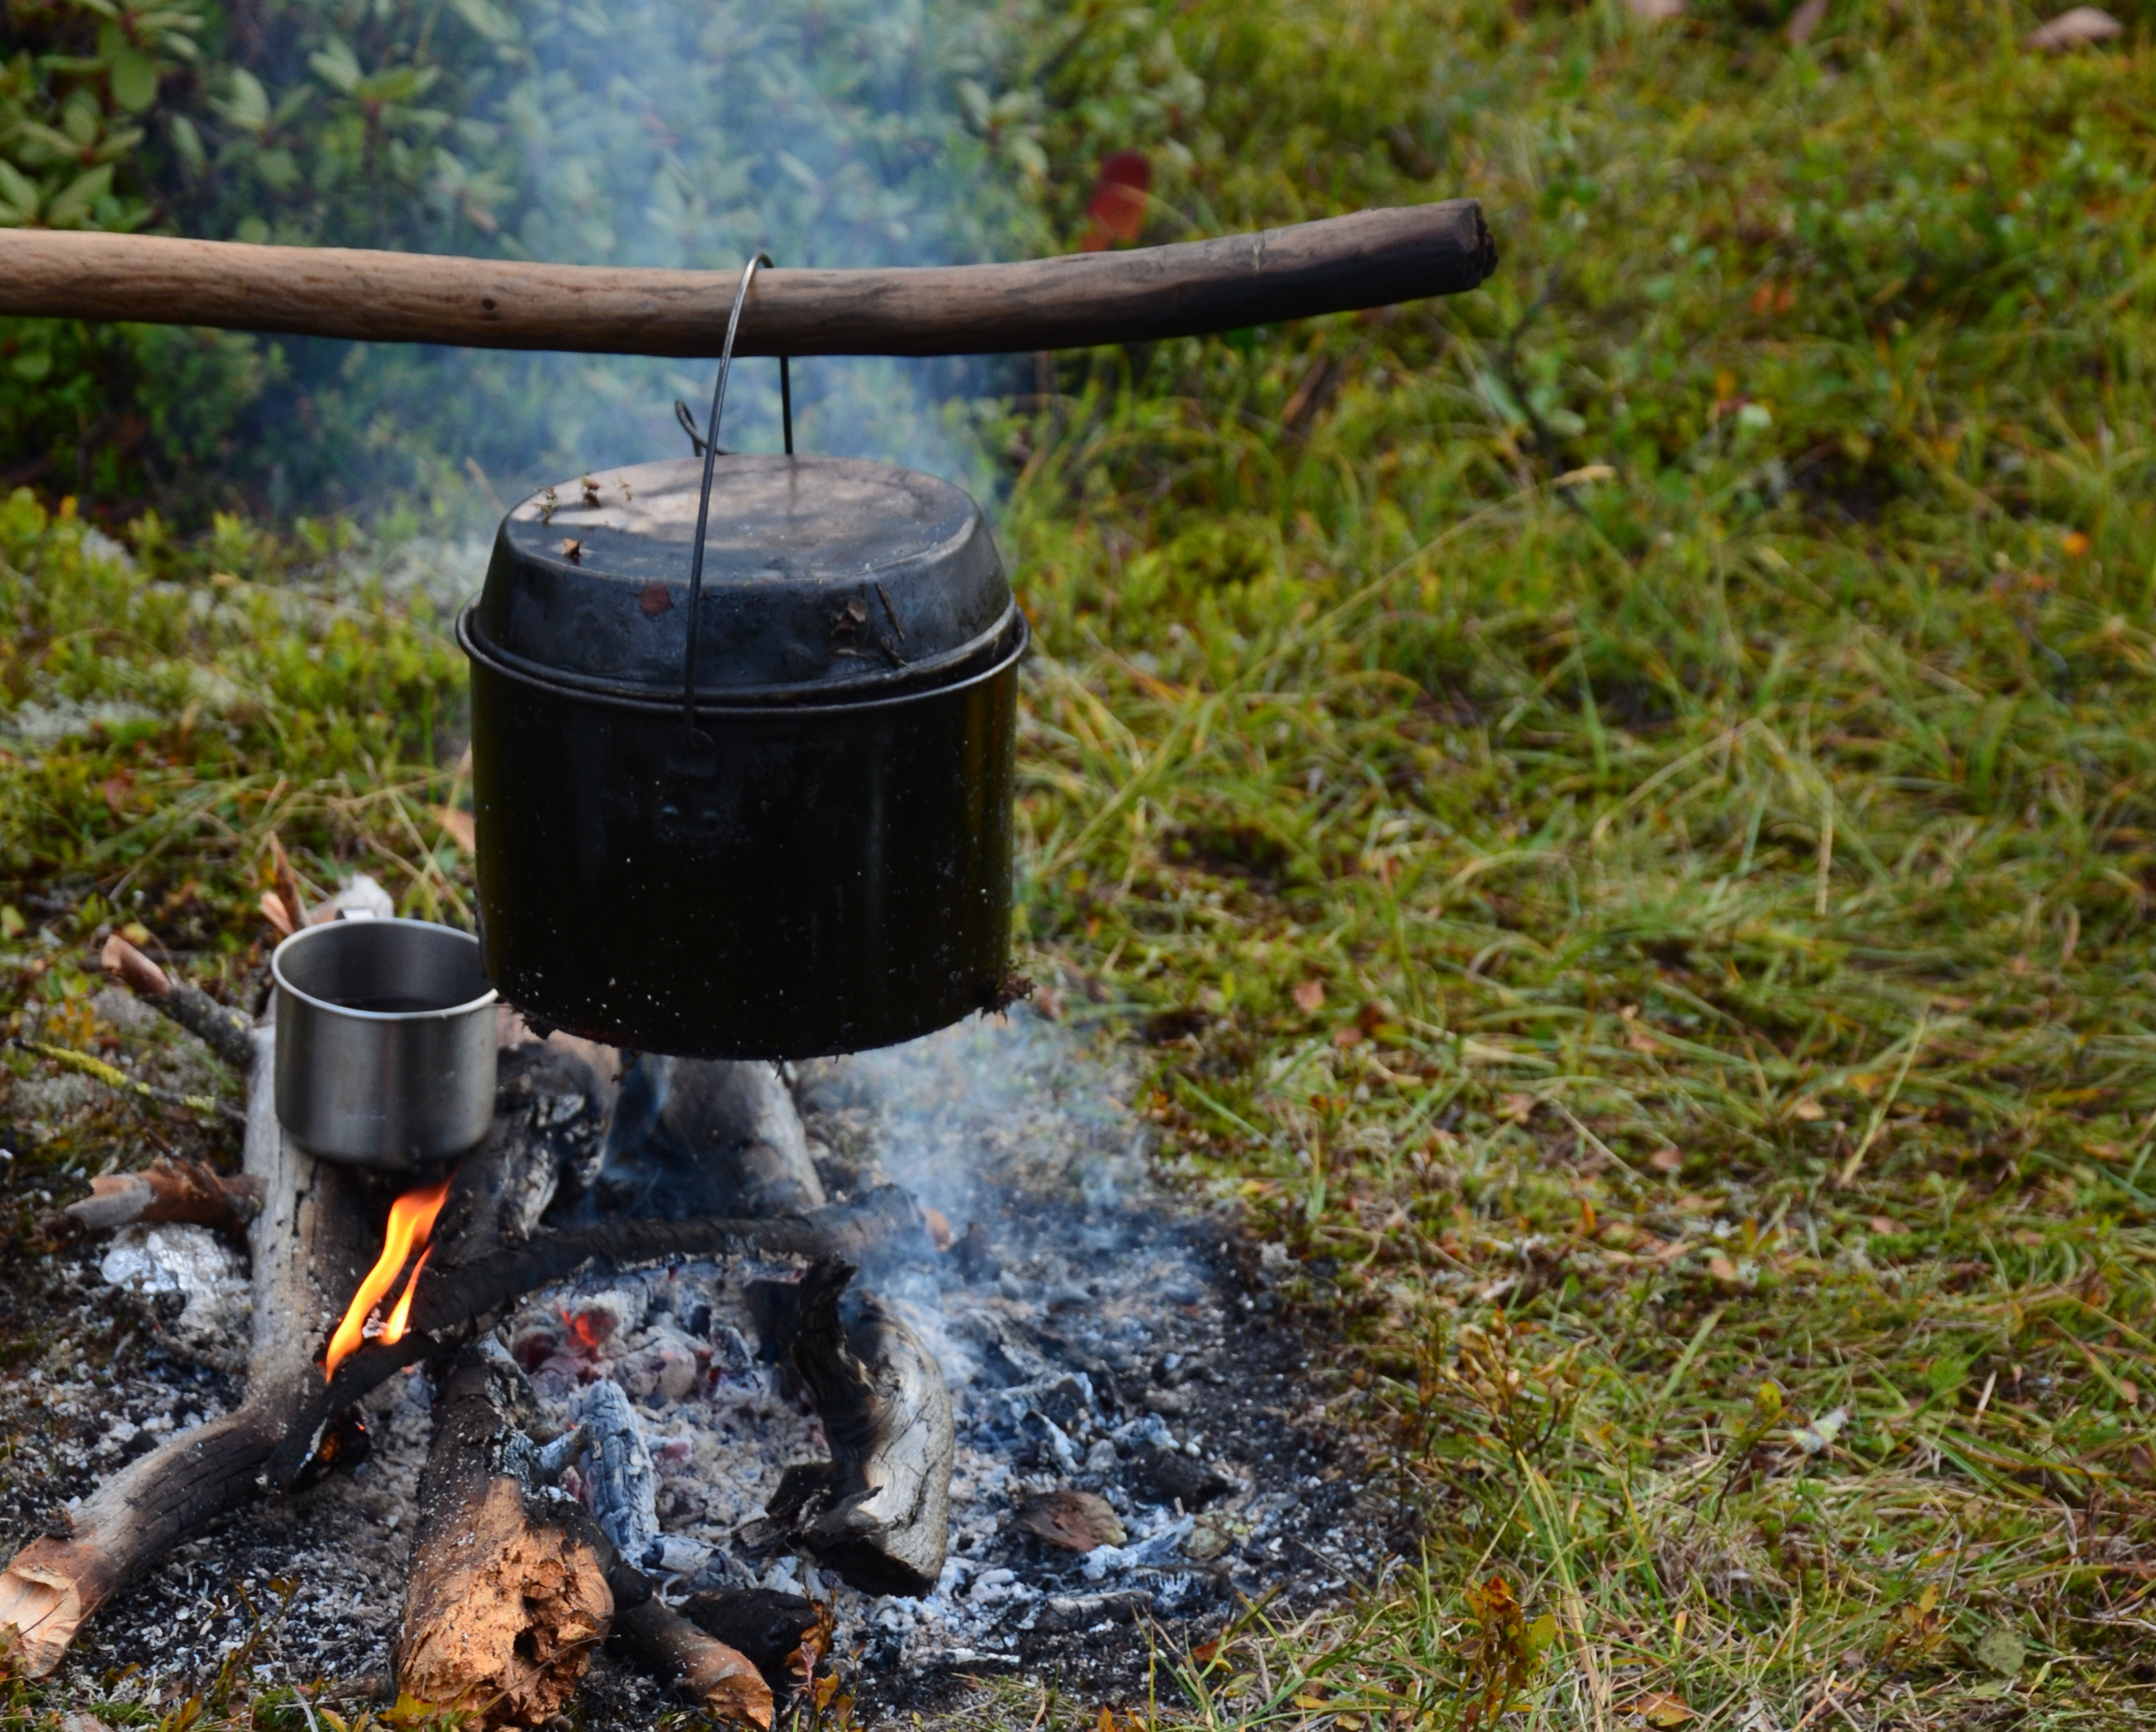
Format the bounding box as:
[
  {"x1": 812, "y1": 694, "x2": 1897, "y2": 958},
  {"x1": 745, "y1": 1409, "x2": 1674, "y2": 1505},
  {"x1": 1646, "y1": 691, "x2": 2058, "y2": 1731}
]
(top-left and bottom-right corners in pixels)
[{"x1": 270, "y1": 0, "x2": 1037, "y2": 518}]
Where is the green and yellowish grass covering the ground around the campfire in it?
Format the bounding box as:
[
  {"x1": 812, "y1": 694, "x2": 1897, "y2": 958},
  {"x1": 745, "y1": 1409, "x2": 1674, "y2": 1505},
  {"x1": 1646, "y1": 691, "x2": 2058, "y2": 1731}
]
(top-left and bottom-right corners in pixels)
[{"x1": 0, "y1": 0, "x2": 2156, "y2": 1732}]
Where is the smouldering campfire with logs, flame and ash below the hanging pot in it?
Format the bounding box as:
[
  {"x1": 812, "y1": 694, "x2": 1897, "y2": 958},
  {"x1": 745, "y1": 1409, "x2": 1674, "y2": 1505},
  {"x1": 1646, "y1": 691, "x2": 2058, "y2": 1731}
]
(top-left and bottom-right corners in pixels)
[{"x1": 0, "y1": 906, "x2": 1386, "y2": 1725}]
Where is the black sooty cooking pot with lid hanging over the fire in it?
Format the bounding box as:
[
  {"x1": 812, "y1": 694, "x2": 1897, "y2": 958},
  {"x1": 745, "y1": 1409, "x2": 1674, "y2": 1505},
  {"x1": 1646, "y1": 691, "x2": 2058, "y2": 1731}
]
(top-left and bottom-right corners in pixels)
[{"x1": 457, "y1": 455, "x2": 1026, "y2": 1059}]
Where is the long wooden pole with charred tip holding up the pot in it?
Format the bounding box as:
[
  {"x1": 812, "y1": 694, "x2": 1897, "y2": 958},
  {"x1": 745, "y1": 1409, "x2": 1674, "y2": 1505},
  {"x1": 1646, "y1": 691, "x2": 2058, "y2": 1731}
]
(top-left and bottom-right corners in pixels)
[{"x1": 0, "y1": 198, "x2": 1496, "y2": 358}]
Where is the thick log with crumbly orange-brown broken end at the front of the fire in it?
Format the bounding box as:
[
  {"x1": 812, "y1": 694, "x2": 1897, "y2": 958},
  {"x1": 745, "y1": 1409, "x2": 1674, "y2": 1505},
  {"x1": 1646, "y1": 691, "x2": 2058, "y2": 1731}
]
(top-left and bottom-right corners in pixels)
[{"x1": 394, "y1": 1348, "x2": 614, "y2": 1725}]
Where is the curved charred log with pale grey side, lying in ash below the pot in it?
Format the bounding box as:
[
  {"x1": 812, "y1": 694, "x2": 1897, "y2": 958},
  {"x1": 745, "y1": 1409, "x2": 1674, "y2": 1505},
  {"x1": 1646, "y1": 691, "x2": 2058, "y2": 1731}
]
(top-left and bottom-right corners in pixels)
[{"x1": 754, "y1": 1258, "x2": 957, "y2": 1594}]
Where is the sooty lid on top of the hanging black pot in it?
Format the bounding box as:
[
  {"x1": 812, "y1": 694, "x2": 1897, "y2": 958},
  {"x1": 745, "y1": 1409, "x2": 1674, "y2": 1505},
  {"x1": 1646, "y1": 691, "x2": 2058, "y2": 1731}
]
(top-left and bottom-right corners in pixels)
[{"x1": 470, "y1": 455, "x2": 1011, "y2": 701}]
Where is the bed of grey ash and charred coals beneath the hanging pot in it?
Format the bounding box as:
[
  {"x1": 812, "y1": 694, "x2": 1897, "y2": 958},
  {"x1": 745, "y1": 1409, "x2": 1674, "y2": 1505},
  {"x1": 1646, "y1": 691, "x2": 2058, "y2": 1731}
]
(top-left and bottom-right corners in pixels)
[{"x1": 34, "y1": 1016, "x2": 1388, "y2": 1719}]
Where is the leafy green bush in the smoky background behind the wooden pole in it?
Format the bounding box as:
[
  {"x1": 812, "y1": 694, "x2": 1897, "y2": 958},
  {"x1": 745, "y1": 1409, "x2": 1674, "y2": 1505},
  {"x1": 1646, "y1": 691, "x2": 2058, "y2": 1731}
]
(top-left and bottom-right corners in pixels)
[{"x1": 0, "y1": 0, "x2": 1203, "y2": 522}]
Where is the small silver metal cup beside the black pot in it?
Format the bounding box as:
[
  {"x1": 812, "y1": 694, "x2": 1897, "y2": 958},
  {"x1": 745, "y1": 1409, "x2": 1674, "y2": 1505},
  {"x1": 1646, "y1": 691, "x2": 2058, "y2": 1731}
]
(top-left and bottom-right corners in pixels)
[{"x1": 270, "y1": 917, "x2": 498, "y2": 1169}]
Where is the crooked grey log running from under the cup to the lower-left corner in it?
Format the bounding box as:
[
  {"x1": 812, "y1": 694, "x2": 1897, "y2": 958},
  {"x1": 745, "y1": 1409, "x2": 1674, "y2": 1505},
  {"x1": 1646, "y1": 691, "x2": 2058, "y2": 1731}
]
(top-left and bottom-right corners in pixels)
[{"x1": 0, "y1": 1029, "x2": 379, "y2": 1678}]
